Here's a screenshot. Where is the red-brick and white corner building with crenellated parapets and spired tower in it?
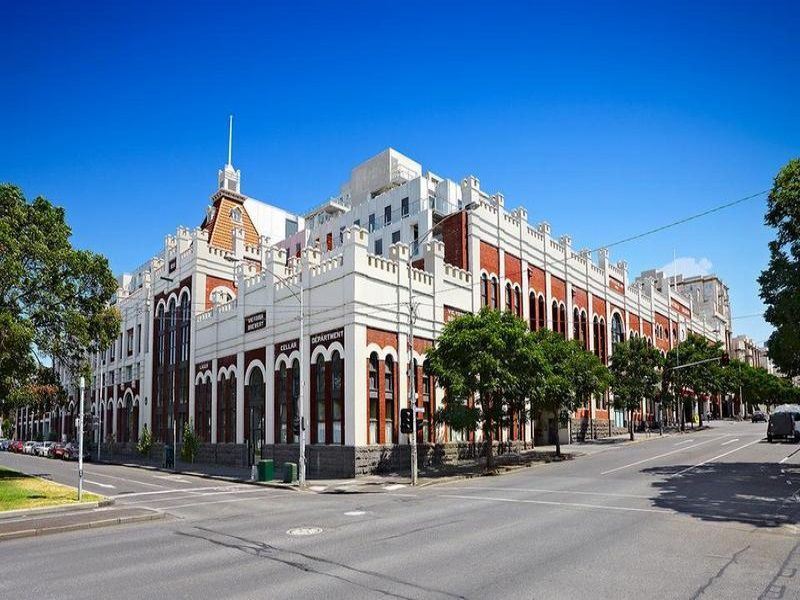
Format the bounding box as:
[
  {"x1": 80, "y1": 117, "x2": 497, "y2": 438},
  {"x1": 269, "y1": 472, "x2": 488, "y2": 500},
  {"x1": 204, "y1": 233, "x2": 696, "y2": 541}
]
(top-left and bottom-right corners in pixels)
[{"x1": 49, "y1": 149, "x2": 730, "y2": 477}]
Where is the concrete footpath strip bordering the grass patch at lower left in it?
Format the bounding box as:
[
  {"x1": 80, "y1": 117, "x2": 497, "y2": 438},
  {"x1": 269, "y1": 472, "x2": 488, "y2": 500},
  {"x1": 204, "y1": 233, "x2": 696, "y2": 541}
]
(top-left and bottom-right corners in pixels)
[{"x1": 0, "y1": 504, "x2": 164, "y2": 542}]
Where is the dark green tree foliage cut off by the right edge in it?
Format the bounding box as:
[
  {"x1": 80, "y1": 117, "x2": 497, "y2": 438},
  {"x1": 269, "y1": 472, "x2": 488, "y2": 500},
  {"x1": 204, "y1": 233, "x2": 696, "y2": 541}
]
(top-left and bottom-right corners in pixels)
[{"x1": 758, "y1": 158, "x2": 800, "y2": 376}]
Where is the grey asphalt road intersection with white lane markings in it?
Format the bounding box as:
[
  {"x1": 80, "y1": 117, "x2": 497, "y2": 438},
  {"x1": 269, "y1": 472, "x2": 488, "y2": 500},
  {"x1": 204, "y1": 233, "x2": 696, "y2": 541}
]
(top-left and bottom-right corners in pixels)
[{"x1": 0, "y1": 423, "x2": 800, "y2": 599}]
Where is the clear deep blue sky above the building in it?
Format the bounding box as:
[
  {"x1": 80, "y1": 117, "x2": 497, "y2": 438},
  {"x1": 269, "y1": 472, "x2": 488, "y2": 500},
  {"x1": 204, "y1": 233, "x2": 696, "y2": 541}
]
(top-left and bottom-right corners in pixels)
[{"x1": 0, "y1": 2, "x2": 800, "y2": 340}]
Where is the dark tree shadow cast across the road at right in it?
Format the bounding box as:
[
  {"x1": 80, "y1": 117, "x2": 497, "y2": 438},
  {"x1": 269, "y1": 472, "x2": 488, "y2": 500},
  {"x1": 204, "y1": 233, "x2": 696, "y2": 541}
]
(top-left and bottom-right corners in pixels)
[{"x1": 642, "y1": 463, "x2": 800, "y2": 527}]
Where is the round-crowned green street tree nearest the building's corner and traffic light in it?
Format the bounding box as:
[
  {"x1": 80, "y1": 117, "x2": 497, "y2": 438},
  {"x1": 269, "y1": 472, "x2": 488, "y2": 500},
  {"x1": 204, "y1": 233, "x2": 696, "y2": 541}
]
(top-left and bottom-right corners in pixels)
[{"x1": 425, "y1": 308, "x2": 543, "y2": 472}]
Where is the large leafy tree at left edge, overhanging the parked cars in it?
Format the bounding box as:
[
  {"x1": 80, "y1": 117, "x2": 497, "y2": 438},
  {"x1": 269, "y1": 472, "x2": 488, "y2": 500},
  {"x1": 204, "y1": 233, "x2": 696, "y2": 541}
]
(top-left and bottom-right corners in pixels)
[{"x1": 0, "y1": 184, "x2": 120, "y2": 420}]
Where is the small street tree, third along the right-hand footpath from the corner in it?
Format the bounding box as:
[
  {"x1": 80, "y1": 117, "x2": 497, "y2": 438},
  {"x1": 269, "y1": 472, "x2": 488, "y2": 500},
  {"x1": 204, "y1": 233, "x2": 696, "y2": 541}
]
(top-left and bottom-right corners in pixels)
[{"x1": 609, "y1": 337, "x2": 664, "y2": 440}]
